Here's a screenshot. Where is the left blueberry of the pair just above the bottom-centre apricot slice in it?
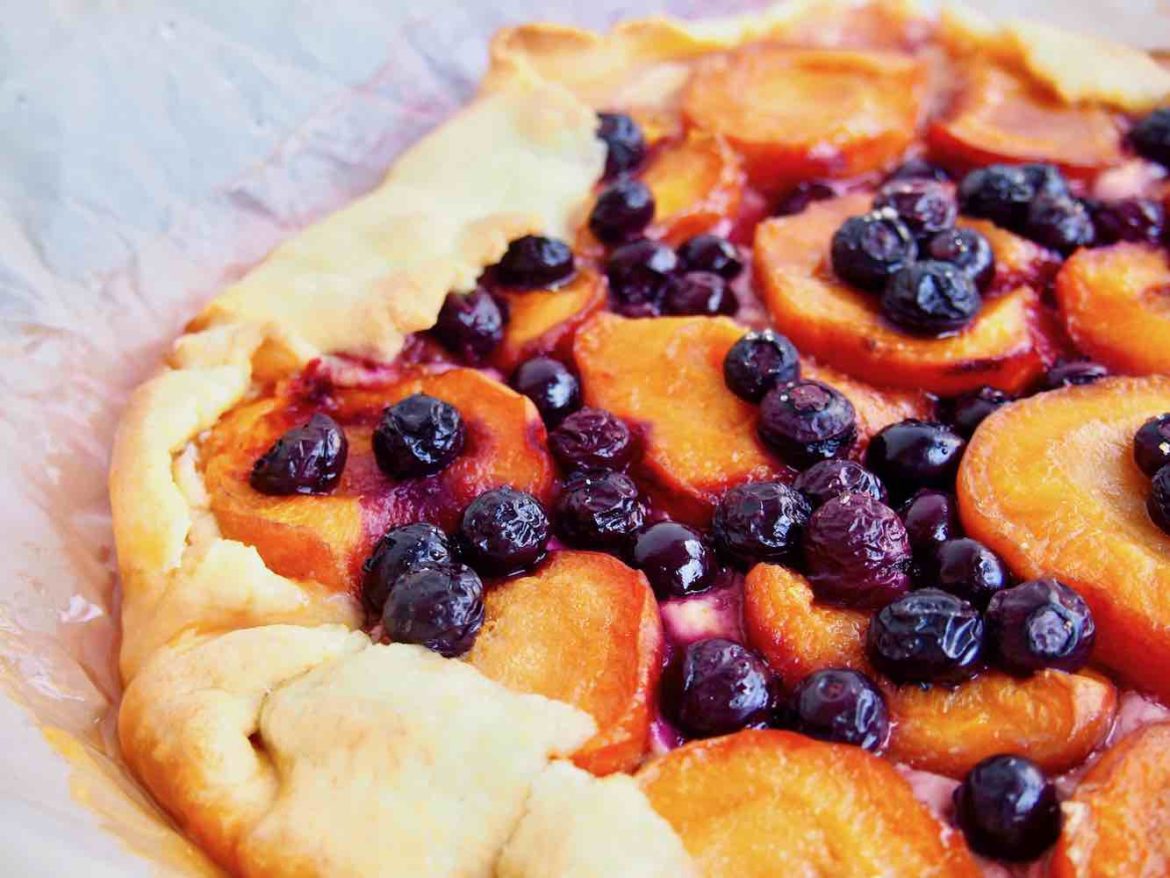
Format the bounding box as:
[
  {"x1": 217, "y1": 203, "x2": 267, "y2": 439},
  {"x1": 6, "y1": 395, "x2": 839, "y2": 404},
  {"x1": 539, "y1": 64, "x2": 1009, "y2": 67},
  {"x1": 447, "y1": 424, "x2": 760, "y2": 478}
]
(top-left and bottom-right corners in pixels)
[{"x1": 662, "y1": 638, "x2": 772, "y2": 738}]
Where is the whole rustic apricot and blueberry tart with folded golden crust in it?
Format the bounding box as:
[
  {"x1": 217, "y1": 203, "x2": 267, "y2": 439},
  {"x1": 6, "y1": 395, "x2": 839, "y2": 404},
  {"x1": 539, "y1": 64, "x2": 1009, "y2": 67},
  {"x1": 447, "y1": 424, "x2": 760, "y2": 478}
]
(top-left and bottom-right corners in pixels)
[{"x1": 110, "y1": 0, "x2": 1170, "y2": 878}]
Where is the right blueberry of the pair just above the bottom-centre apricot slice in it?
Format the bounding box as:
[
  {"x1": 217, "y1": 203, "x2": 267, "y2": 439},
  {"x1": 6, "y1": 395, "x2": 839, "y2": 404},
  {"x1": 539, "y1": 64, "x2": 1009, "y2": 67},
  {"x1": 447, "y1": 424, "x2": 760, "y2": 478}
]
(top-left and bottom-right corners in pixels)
[{"x1": 792, "y1": 667, "x2": 889, "y2": 750}]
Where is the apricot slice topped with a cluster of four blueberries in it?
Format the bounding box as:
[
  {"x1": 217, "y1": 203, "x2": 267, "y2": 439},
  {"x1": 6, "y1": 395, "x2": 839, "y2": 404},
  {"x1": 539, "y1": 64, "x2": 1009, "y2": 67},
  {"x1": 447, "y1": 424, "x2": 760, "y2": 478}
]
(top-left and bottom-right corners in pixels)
[{"x1": 753, "y1": 196, "x2": 1042, "y2": 395}]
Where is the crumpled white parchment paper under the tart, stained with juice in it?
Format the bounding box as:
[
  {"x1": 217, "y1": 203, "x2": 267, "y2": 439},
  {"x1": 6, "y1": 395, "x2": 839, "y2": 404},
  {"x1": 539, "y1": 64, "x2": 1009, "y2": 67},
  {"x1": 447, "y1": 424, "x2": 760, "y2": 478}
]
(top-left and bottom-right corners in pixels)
[{"x1": 0, "y1": 0, "x2": 1170, "y2": 876}]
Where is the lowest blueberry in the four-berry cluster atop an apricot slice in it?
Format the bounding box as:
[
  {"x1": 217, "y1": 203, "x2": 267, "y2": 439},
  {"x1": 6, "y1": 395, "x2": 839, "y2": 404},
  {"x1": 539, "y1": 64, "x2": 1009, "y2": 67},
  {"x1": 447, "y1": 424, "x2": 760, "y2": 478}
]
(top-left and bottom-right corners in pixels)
[{"x1": 881, "y1": 260, "x2": 983, "y2": 338}]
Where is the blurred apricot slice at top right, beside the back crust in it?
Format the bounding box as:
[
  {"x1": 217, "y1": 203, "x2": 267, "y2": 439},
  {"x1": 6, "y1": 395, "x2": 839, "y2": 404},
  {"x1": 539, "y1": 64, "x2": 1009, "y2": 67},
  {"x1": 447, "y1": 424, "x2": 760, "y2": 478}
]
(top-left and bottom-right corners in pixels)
[{"x1": 928, "y1": 62, "x2": 1123, "y2": 177}]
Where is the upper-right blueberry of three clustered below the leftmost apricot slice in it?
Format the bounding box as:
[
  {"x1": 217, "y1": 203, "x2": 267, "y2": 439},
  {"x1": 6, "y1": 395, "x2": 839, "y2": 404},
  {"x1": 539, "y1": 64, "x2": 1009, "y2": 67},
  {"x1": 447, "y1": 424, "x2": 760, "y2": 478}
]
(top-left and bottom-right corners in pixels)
[{"x1": 460, "y1": 487, "x2": 549, "y2": 576}]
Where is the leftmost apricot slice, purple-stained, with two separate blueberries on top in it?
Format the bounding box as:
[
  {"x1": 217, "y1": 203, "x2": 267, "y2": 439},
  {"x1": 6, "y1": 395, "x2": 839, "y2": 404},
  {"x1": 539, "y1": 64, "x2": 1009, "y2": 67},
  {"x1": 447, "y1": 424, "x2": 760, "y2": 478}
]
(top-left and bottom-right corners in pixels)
[{"x1": 200, "y1": 369, "x2": 553, "y2": 590}]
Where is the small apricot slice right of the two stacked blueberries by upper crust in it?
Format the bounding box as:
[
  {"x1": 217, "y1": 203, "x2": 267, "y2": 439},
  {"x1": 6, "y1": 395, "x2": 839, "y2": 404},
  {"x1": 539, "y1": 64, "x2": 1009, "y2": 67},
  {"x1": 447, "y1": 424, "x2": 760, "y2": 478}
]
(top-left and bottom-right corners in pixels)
[{"x1": 642, "y1": 131, "x2": 744, "y2": 245}]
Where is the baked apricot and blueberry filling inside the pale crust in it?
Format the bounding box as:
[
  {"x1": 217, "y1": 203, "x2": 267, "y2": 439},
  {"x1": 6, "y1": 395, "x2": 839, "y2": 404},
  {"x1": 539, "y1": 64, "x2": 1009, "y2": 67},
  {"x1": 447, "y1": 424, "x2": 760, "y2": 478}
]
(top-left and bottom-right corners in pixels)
[{"x1": 187, "y1": 11, "x2": 1170, "y2": 876}]
